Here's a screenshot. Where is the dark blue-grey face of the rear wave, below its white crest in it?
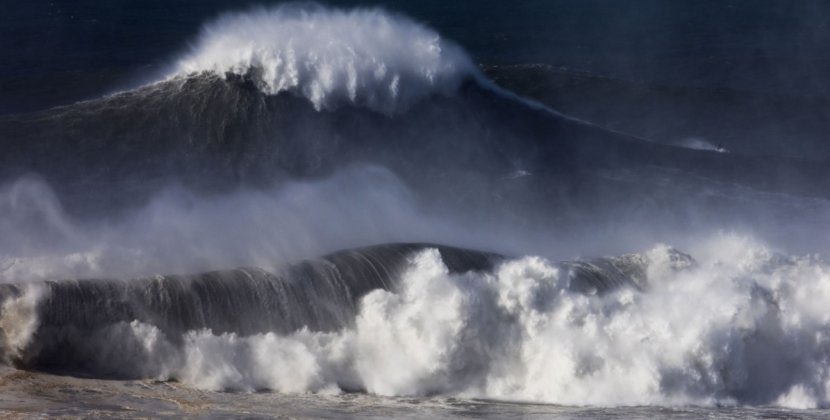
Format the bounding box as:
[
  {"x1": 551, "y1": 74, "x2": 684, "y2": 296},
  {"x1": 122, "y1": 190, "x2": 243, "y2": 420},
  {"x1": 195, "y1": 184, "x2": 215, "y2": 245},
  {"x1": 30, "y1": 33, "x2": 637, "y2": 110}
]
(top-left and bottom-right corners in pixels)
[{"x1": 0, "y1": 75, "x2": 830, "y2": 216}]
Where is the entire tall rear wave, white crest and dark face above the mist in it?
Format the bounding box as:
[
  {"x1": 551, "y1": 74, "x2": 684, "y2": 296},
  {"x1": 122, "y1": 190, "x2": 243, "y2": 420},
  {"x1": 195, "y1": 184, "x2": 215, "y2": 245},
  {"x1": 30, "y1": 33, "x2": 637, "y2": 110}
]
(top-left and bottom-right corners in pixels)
[{"x1": 0, "y1": 5, "x2": 830, "y2": 223}]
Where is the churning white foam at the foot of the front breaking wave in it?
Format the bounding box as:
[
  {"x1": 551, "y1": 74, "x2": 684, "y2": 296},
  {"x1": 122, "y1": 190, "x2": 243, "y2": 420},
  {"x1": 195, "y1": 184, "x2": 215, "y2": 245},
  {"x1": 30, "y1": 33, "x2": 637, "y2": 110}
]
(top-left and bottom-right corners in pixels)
[{"x1": 32, "y1": 236, "x2": 830, "y2": 408}]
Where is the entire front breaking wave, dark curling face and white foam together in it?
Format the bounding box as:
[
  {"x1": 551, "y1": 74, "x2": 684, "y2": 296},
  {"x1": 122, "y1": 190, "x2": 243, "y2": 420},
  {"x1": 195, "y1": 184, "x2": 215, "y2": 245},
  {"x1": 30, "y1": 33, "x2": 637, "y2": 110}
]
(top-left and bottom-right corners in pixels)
[{"x1": 0, "y1": 236, "x2": 830, "y2": 407}]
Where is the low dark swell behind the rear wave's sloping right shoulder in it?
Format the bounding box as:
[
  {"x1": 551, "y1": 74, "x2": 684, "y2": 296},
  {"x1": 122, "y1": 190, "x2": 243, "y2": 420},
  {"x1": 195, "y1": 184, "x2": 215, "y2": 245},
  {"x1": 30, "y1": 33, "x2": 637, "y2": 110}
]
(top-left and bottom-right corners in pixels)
[{"x1": 483, "y1": 64, "x2": 830, "y2": 161}]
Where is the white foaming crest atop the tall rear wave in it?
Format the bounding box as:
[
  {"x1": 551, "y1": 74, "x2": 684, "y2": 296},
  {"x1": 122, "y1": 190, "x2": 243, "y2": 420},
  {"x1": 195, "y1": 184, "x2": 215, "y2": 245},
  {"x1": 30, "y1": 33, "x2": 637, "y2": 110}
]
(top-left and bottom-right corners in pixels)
[{"x1": 175, "y1": 5, "x2": 477, "y2": 114}]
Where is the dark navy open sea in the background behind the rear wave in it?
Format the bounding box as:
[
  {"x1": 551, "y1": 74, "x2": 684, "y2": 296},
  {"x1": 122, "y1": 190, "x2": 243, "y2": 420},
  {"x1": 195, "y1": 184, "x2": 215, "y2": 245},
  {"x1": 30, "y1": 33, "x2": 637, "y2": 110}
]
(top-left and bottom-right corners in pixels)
[{"x1": 0, "y1": 0, "x2": 830, "y2": 113}]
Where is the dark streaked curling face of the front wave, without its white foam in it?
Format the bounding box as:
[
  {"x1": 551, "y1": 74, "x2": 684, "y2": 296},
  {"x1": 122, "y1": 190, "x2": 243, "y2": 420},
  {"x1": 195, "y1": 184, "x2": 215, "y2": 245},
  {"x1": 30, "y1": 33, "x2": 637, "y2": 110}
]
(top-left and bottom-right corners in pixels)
[{"x1": 0, "y1": 244, "x2": 644, "y2": 377}]
